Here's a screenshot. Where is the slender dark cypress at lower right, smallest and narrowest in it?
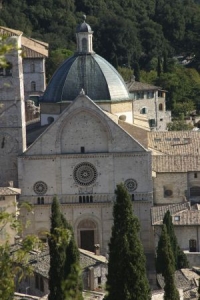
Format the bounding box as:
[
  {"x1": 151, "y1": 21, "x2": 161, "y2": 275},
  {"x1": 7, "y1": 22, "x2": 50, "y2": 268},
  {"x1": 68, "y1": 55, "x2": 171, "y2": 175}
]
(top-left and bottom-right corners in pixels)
[{"x1": 159, "y1": 224, "x2": 180, "y2": 300}]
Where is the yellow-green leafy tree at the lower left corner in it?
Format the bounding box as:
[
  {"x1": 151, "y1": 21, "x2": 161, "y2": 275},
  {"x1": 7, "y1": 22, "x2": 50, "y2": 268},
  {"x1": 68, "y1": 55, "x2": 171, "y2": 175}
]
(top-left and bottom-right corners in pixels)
[{"x1": 0, "y1": 204, "x2": 41, "y2": 300}]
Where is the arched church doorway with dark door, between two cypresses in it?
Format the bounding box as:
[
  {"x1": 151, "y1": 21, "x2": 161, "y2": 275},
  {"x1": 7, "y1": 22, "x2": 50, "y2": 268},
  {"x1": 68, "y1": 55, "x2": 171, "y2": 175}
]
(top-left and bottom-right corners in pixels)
[{"x1": 77, "y1": 219, "x2": 98, "y2": 252}]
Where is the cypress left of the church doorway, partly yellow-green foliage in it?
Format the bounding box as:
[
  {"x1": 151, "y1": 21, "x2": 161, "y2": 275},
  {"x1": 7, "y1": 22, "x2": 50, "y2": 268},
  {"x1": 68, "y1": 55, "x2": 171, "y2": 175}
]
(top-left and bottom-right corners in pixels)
[{"x1": 48, "y1": 197, "x2": 82, "y2": 300}]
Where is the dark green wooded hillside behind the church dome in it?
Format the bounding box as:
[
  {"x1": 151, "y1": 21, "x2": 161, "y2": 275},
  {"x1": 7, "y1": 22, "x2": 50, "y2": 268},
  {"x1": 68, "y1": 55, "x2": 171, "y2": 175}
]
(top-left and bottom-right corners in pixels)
[{"x1": 0, "y1": 0, "x2": 200, "y2": 117}]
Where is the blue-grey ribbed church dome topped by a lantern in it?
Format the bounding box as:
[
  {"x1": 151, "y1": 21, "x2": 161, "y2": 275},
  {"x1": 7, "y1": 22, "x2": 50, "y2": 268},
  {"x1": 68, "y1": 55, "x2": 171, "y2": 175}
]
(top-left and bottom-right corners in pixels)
[{"x1": 41, "y1": 21, "x2": 129, "y2": 103}]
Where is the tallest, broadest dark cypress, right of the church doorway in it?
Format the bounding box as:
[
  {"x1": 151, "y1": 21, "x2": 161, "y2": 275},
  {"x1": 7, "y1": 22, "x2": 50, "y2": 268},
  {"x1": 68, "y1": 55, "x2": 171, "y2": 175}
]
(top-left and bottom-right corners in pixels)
[{"x1": 105, "y1": 184, "x2": 151, "y2": 300}]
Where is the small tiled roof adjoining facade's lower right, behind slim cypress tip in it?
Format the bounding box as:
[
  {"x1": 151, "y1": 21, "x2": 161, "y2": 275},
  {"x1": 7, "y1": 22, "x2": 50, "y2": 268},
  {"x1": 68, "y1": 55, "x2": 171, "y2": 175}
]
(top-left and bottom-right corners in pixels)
[{"x1": 151, "y1": 202, "x2": 190, "y2": 225}]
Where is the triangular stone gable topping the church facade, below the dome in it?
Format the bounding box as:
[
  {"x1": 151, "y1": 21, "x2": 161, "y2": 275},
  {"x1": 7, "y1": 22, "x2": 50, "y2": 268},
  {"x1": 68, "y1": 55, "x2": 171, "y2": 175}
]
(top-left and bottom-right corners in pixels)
[{"x1": 24, "y1": 95, "x2": 147, "y2": 155}]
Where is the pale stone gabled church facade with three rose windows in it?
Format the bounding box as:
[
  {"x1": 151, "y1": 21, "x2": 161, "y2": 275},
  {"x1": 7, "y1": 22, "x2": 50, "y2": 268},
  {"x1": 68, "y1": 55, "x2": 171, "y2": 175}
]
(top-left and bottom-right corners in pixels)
[{"x1": 18, "y1": 95, "x2": 152, "y2": 254}]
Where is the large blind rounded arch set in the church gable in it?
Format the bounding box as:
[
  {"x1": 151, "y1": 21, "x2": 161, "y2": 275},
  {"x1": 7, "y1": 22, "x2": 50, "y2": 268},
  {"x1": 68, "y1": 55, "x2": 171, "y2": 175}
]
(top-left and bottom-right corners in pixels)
[{"x1": 56, "y1": 108, "x2": 112, "y2": 153}]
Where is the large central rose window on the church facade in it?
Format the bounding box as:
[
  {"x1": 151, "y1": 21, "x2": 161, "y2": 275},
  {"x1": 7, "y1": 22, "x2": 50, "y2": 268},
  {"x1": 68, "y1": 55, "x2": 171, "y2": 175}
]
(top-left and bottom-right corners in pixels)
[{"x1": 73, "y1": 162, "x2": 97, "y2": 186}]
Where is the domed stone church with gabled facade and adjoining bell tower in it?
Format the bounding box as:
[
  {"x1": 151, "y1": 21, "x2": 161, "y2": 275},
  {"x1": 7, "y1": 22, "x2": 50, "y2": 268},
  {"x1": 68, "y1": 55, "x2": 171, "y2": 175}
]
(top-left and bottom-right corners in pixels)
[{"x1": 0, "y1": 21, "x2": 156, "y2": 254}]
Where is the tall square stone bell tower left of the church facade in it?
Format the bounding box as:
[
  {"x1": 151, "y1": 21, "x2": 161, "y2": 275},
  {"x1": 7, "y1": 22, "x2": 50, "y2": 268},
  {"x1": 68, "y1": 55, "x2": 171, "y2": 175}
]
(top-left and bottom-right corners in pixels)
[{"x1": 0, "y1": 36, "x2": 26, "y2": 187}]
